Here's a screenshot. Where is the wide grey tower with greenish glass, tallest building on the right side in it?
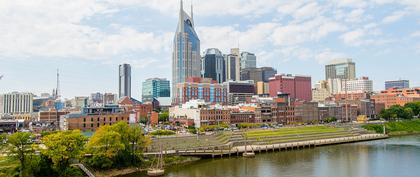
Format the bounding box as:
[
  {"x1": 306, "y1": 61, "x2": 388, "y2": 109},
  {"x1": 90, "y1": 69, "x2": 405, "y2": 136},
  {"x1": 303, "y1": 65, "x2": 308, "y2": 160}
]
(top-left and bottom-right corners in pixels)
[{"x1": 325, "y1": 59, "x2": 356, "y2": 80}]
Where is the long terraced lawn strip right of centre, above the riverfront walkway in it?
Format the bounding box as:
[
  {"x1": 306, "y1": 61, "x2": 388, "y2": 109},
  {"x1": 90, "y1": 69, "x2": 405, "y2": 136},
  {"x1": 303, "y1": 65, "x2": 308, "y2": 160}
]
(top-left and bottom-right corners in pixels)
[{"x1": 245, "y1": 126, "x2": 344, "y2": 138}]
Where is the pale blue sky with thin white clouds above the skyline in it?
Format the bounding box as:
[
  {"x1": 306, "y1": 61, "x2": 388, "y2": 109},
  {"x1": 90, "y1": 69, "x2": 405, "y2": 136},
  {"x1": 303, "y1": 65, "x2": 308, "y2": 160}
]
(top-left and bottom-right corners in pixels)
[{"x1": 0, "y1": 0, "x2": 420, "y2": 98}]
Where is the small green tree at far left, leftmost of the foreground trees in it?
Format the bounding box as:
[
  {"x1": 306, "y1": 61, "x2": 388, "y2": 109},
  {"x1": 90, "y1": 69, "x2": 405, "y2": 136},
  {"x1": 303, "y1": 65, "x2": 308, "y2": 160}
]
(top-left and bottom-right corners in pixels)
[{"x1": 7, "y1": 132, "x2": 34, "y2": 176}]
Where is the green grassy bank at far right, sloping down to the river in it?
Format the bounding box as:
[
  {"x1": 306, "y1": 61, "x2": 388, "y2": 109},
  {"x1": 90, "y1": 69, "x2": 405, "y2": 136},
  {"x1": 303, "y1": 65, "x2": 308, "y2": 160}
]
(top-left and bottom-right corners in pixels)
[{"x1": 362, "y1": 120, "x2": 420, "y2": 136}]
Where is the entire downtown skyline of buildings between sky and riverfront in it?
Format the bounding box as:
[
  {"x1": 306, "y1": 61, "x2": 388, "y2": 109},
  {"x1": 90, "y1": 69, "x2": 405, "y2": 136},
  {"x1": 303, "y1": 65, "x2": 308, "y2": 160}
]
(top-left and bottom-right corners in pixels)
[{"x1": 0, "y1": 1, "x2": 420, "y2": 131}]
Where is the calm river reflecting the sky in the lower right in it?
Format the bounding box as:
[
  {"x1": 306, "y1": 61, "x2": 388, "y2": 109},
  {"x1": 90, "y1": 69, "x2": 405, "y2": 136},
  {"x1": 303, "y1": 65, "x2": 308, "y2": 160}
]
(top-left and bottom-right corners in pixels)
[{"x1": 124, "y1": 136, "x2": 420, "y2": 177}]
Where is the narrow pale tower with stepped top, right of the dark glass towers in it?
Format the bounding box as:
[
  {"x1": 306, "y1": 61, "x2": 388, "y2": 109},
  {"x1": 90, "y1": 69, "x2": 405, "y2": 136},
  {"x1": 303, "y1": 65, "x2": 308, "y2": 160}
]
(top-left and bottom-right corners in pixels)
[{"x1": 225, "y1": 48, "x2": 241, "y2": 81}]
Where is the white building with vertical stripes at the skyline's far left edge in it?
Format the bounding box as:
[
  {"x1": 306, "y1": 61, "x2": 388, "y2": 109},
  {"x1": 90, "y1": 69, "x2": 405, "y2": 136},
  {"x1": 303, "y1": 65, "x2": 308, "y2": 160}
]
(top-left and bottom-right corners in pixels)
[{"x1": 0, "y1": 92, "x2": 33, "y2": 115}]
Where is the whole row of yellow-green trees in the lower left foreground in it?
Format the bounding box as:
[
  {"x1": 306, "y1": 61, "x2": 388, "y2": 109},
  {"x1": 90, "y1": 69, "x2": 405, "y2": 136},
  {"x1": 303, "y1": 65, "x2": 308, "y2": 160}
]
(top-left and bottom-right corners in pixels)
[{"x1": 0, "y1": 122, "x2": 150, "y2": 177}]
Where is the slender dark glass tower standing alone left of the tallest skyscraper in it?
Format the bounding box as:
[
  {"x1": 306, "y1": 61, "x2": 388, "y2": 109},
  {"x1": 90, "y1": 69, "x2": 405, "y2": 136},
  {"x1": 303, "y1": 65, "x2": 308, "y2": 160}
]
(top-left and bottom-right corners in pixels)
[{"x1": 118, "y1": 64, "x2": 131, "y2": 98}]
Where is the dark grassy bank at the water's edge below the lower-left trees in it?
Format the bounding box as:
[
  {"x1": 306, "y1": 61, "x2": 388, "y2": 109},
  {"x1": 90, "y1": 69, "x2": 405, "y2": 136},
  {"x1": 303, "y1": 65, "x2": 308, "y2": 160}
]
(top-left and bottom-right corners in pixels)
[{"x1": 93, "y1": 156, "x2": 201, "y2": 177}]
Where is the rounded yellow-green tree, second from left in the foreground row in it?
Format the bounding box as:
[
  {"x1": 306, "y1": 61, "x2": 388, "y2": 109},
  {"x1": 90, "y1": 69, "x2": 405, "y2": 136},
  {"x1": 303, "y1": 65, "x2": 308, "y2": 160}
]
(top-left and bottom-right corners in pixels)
[{"x1": 41, "y1": 130, "x2": 86, "y2": 173}]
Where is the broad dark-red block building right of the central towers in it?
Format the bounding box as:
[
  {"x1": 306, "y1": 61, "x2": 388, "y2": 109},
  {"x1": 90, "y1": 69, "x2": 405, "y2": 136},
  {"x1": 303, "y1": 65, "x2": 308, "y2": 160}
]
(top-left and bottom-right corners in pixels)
[{"x1": 269, "y1": 74, "x2": 312, "y2": 101}]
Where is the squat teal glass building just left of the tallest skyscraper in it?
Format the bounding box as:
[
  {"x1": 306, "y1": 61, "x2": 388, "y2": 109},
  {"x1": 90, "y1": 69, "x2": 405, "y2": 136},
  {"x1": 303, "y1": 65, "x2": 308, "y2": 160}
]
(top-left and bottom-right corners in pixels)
[{"x1": 141, "y1": 78, "x2": 171, "y2": 102}]
